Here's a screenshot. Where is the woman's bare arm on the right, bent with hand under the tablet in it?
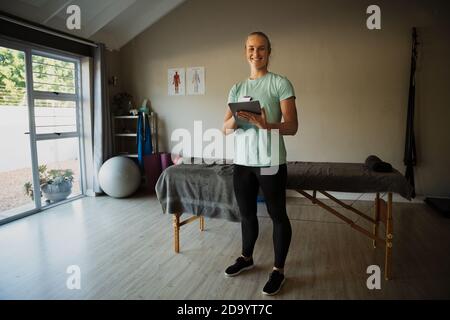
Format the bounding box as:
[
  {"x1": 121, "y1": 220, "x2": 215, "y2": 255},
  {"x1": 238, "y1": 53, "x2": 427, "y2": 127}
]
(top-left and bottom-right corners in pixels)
[{"x1": 238, "y1": 97, "x2": 298, "y2": 136}]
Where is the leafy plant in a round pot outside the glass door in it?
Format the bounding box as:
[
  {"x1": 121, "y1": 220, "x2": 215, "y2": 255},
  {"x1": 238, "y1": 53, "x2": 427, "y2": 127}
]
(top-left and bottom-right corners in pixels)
[{"x1": 24, "y1": 165, "x2": 73, "y2": 202}]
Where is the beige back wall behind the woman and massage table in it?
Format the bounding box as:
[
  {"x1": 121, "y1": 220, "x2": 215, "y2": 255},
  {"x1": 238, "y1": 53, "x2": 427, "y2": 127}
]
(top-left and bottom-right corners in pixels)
[{"x1": 119, "y1": 0, "x2": 450, "y2": 196}]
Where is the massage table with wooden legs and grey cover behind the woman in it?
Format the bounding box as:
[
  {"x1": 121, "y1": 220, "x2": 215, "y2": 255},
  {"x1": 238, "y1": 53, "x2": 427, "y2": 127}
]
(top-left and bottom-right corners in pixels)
[{"x1": 155, "y1": 161, "x2": 412, "y2": 279}]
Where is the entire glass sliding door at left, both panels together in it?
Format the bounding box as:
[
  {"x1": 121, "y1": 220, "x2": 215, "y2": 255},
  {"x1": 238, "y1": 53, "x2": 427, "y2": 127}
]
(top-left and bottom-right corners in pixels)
[{"x1": 0, "y1": 41, "x2": 84, "y2": 224}]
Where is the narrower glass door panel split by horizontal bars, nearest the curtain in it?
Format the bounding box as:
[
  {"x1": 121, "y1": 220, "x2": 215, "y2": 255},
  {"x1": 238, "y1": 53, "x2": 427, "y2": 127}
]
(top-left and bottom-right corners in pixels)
[{"x1": 31, "y1": 51, "x2": 82, "y2": 207}]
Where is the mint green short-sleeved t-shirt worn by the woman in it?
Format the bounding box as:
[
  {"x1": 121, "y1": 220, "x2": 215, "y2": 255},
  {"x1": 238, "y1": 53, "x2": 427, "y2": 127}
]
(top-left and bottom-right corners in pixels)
[{"x1": 228, "y1": 72, "x2": 295, "y2": 167}]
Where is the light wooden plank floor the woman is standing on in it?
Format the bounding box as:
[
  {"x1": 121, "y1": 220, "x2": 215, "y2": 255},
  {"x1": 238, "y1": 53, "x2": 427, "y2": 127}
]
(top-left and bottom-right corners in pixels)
[{"x1": 0, "y1": 189, "x2": 450, "y2": 299}]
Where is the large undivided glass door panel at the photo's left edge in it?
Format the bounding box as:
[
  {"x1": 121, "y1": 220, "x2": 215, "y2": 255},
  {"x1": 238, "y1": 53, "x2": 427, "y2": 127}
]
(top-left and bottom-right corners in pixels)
[{"x1": 0, "y1": 46, "x2": 36, "y2": 221}]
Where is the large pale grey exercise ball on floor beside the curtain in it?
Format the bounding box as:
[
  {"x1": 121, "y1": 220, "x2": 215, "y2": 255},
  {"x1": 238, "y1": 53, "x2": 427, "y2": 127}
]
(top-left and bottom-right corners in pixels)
[{"x1": 98, "y1": 156, "x2": 141, "y2": 198}]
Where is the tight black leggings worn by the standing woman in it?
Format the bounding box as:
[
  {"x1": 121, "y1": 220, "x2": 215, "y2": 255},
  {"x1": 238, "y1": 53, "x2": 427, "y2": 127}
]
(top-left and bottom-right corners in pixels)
[{"x1": 233, "y1": 164, "x2": 292, "y2": 268}]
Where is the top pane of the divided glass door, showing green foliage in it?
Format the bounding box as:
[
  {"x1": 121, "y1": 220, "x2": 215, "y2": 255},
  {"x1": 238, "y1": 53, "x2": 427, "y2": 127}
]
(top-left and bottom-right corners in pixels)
[{"x1": 32, "y1": 55, "x2": 75, "y2": 94}]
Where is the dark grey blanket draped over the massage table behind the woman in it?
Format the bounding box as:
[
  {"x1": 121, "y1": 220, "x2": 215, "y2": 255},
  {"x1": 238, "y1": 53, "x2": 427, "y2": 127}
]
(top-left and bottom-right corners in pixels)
[{"x1": 155, "y1": 162, "x2": 411, "y2": 221}]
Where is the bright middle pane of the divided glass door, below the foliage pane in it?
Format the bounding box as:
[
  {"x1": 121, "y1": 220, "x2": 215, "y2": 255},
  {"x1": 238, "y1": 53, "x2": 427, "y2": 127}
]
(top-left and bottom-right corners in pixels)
[{"x1": 34, "y1": 99, "x2": 77, "y2": 134}]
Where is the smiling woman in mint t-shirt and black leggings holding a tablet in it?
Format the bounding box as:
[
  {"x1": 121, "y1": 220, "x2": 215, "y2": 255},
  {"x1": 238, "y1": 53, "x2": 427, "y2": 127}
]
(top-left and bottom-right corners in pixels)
[{"x1": 223, "y1": 32, "x2": 298, "y2": 295}]
